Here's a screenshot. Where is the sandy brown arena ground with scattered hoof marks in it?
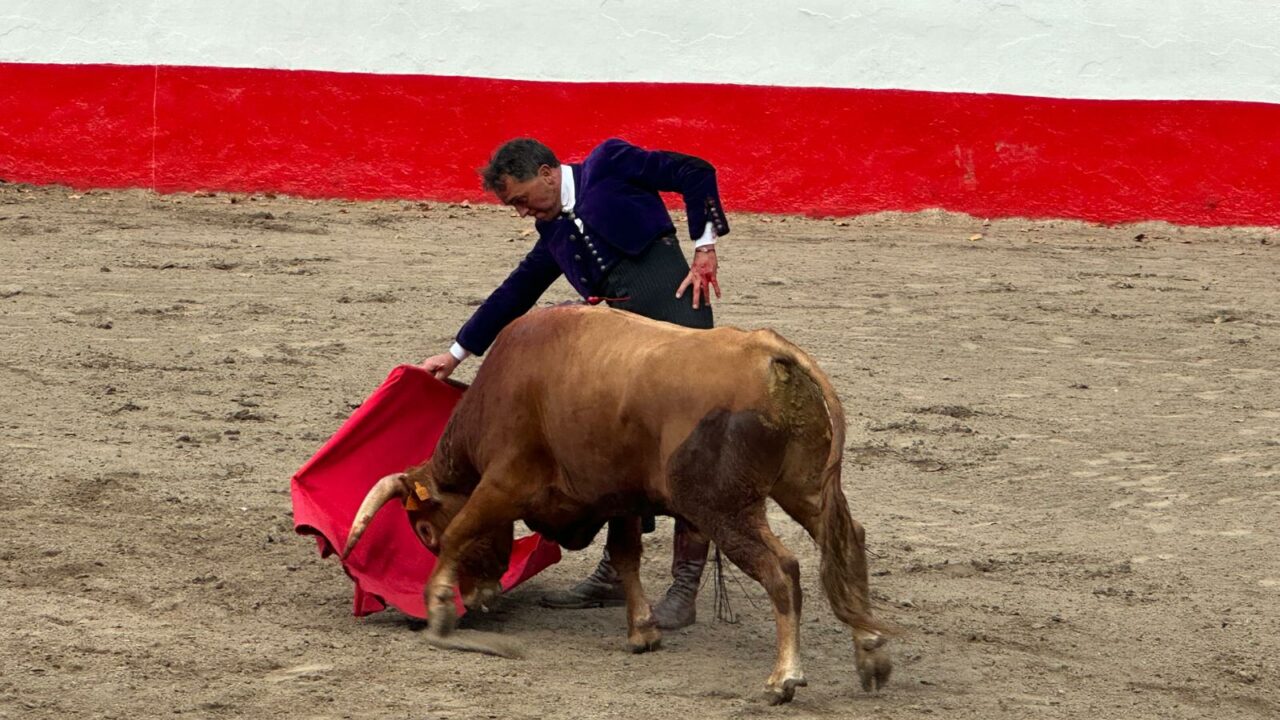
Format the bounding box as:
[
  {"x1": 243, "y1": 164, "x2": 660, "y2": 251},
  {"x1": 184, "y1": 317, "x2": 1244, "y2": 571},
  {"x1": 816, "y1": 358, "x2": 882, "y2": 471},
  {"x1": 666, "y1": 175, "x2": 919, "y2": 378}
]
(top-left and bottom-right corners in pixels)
[{"x1": 0, "y1": 184, "x2": 1280, "y2": 720}]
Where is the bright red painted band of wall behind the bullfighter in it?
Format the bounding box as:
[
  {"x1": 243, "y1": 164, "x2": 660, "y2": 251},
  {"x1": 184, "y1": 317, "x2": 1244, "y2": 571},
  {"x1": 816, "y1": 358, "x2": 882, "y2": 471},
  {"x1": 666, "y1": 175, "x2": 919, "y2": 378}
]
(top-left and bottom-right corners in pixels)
[{"x1": 0, "y1": 64, "x2": 1280, "y2": 225}]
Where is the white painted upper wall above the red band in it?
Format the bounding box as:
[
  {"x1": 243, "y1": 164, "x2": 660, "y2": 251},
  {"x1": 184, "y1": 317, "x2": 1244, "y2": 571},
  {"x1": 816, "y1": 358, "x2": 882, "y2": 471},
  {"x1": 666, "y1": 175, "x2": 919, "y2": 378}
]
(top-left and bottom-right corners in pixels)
[{"x1": 0, "y1": 0, "x2": 1280, "y2": 102}]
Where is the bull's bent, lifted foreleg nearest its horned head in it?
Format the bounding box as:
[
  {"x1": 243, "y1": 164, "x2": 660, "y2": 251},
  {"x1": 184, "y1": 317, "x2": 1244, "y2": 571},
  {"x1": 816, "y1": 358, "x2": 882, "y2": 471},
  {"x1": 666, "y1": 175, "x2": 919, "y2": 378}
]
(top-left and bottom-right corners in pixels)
[{"x1": 424, "y1": 482, "x2": 518, "y2": 637}]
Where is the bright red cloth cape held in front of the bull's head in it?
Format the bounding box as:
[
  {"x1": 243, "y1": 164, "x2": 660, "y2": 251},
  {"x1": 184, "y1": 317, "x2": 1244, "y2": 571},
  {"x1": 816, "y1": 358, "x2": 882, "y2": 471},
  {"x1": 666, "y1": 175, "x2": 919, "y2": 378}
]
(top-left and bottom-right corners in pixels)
[{"x1": 292, "y1": 365, "x2": 561, "y2": 618}]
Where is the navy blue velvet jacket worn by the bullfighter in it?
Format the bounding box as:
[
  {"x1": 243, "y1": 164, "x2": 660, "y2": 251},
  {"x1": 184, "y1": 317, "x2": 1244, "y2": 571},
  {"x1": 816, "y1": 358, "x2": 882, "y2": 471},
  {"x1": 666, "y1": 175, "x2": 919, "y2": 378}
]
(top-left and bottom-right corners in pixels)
[{"x1": 457, "y1": 138, "x2": 728, "y2": 355}]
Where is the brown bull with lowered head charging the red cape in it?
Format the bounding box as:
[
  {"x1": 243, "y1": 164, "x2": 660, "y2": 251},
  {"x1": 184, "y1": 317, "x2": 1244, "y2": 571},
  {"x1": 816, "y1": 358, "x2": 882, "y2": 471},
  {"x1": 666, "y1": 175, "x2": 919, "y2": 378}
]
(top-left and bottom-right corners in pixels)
[{"x1": 347, "y1": 306, "x2": 891, "y2": 702}]
